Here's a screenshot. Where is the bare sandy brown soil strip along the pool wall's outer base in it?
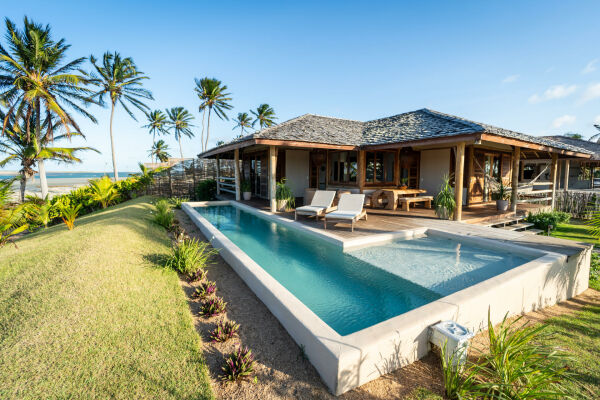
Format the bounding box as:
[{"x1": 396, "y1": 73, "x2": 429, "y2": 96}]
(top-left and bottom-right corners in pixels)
[{"x1": 172, "y1": 210, "x2": 600, "y2": 400}]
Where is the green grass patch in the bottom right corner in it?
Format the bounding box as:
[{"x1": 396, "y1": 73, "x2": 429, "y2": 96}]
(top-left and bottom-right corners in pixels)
[{"x1": 546, "y1": 304, "x2": 600, "y2": 400}]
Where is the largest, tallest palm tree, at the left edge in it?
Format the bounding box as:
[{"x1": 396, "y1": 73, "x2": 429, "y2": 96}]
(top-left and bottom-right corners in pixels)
[{"x1": 0, "y1": 17, "x2": 96, "y2": 197}]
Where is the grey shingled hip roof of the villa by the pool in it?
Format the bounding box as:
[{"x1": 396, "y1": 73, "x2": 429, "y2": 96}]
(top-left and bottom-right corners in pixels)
[{"x1": 200, "y1": 108, "x2": 593, "y2": 154}]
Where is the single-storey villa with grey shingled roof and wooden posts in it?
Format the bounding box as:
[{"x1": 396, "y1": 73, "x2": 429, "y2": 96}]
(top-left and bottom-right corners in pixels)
[{"x1": 199, "y1": 109, "x2": 593, "y2": 221}]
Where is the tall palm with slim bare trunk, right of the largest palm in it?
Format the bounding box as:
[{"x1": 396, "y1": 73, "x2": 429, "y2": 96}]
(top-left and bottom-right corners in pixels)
[{"x1": 90, "y1": 52, "x2": 153, "y2": 181}]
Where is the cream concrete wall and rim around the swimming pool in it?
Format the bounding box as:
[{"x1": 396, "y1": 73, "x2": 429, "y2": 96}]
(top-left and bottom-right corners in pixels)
[{"x1": 182, "y1": 201, "x2": 591, "y2": 395}]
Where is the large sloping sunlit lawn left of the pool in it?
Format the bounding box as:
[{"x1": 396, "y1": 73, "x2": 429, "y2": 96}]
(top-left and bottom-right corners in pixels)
[{"x1": 0, "y1": 197, "x2": 213, "y2": 399}]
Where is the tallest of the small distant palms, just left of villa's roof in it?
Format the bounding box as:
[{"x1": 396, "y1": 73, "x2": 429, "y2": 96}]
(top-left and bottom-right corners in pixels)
[{"x1": 194, "y1": 78, "x2": 233, "y2": 152}]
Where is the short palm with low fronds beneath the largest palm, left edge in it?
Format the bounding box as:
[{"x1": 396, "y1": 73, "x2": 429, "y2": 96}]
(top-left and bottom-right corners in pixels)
[{"x1": 0, "y1": 112, "x2": 98, "y2": 202}]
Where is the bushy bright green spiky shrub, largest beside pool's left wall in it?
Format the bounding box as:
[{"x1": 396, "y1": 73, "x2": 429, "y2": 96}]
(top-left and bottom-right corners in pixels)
[{"x1": 166, "y1": 238, "x2": 217, "y2": 277}]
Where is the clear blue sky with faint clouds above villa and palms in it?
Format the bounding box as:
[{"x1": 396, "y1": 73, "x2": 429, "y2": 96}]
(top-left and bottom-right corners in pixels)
[{"x1": 2, "y1": 0, "x2": 600, "y2": 171}]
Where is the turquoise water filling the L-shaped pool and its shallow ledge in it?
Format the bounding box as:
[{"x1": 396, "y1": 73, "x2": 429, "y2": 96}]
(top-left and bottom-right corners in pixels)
[{"x1": 195, "y1": 206, "x2": 529, "y2": 336}]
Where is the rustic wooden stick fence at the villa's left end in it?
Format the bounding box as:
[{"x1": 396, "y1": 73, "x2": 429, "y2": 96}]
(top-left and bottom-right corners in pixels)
[{"x1": 148, "y1": 158, "x2": 234, "y2": 200}]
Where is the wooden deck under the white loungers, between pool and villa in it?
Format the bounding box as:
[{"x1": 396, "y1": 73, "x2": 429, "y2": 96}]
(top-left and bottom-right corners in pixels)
[{"x1": 233, "y1": 200, "x2": 590, "y2": 256}]
